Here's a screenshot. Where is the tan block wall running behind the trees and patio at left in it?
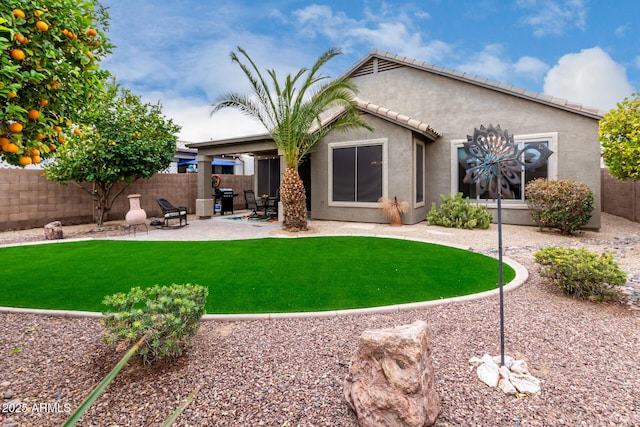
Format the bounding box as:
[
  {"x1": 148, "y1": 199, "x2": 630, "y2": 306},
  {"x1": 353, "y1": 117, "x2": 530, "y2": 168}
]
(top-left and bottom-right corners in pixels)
[{"x1": 0, "y1": 169, "x2": 254, "y2": 232}]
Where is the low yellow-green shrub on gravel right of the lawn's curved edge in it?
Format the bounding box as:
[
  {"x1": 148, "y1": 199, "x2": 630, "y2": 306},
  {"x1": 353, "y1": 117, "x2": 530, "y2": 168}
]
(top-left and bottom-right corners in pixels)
[{"x1": 533, "y1": 247, "x2": 627, "y2": 301}]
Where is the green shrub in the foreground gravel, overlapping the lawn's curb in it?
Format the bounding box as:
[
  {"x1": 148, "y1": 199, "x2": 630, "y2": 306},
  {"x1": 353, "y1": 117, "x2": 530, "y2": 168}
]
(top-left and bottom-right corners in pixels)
[{"x1": 103, "y1": 284, "x2": 208, "y2": 364}]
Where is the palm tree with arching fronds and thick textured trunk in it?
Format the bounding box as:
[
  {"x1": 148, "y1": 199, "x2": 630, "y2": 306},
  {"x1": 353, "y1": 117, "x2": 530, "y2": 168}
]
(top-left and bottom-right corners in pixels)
[{"x1": 211, "y1": 47, "x2": 372, "y2": 231}]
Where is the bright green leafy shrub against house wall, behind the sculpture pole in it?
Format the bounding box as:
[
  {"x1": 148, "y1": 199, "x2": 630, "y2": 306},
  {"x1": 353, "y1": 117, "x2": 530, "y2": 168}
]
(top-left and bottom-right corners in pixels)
[{"x1": 427, "y1": 193, "x2": 493, "y2": 229}]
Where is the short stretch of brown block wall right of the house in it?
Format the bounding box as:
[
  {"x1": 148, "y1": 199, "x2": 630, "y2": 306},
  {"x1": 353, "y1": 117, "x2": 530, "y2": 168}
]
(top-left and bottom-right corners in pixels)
[{"x1": 600, "y1": 169, "x2": 640, "y2": 222}]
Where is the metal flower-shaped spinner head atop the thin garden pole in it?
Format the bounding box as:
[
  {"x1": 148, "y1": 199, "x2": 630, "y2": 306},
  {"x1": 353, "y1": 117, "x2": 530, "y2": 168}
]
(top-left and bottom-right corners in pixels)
[{"x1": 460, "y1": 125, "x2": 553, "y2": 199}]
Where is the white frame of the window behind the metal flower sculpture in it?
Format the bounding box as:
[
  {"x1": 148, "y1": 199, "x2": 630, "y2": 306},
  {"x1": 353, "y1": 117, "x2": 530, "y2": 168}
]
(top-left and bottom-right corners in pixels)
[{"x1": 451, "y1": 132, "x2": 558, "y2": 209}]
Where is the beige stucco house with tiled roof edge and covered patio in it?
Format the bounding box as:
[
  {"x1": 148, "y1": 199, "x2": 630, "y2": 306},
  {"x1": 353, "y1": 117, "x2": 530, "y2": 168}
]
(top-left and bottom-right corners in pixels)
[{"x1": 189, "y1": 51, "x2": 604, "y2": 229}]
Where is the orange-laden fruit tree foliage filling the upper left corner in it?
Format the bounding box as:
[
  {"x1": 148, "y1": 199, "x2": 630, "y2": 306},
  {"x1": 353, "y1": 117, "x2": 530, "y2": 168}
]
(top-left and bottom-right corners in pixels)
[{"x1": 0, "y1": 0, "x2": 112, "y2": 166}]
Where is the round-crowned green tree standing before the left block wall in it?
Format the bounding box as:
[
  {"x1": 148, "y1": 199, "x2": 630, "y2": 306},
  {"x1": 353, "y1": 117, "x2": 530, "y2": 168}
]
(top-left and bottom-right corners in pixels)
[{"x1": 45, "y1": 83, "x2": 180, "y2": 227}]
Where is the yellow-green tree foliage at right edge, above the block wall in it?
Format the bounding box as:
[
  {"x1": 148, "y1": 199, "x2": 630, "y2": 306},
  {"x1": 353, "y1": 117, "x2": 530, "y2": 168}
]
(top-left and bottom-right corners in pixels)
[{"x1": 600, "y1": 92, "x2": 640, "y2": 181}]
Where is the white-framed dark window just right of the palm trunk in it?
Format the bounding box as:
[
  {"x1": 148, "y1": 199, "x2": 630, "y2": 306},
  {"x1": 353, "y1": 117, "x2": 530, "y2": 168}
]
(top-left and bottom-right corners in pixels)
[{"x1": 329, "y1": 140, "x2": 386, "y2": 206}]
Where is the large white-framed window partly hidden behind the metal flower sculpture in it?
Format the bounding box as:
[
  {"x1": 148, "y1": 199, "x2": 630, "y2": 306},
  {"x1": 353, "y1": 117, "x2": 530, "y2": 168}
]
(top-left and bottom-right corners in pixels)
[{"x1": 451, "y1": 132, "x2": 558, "y2": 205}]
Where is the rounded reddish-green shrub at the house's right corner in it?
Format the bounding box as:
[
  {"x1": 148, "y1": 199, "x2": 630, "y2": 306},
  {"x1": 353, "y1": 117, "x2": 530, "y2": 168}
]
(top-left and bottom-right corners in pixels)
[{"x1": 526, "y1": 178, "x2": 593, "y2": 235}]
